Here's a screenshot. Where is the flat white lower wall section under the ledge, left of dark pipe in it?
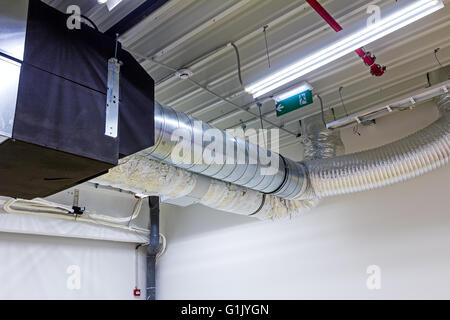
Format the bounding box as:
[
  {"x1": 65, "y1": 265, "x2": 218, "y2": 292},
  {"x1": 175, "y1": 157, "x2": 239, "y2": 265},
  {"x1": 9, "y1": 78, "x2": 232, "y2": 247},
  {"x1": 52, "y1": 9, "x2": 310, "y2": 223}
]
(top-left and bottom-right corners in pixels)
[{"x1": 0, "y1": 232, "x2": 145, "y2": 300}]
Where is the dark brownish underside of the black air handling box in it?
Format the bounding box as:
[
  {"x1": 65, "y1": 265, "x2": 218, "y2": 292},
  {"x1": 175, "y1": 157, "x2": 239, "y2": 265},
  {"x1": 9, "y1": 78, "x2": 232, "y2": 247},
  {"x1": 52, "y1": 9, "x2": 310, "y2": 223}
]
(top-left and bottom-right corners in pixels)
[{"x1": 0, "y1": 139, "x2": 112, "y2": 199}]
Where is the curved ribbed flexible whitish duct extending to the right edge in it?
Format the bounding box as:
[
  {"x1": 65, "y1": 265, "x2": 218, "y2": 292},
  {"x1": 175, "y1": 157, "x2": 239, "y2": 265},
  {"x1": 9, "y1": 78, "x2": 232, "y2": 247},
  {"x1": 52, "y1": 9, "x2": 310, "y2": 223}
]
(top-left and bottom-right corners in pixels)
[{"x1": 298, "y1": 93, "x2": 450, "y2": 199}]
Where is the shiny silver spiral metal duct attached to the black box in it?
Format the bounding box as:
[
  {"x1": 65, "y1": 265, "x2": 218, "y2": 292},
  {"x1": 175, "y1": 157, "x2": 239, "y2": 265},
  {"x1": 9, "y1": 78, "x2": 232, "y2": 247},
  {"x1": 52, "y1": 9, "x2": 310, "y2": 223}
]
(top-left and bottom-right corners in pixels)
[{"x1": 140, "y1": 102, "x2": 304, "y2": 199}]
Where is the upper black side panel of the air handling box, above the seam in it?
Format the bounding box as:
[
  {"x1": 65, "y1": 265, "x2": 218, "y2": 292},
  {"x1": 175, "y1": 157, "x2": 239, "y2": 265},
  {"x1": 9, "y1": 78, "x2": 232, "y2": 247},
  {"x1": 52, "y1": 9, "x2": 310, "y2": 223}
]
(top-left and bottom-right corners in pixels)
[{"x1": 24, "y1": 0, "x2": 115, "y2": 93}]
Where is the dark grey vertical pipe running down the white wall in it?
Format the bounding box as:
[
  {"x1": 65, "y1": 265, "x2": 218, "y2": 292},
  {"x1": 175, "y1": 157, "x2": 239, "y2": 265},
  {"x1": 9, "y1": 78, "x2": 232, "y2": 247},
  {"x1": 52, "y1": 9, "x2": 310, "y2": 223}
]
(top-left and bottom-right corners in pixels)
[{"x1": 146, "y1": 197, "x2": 159, "y2": 300}]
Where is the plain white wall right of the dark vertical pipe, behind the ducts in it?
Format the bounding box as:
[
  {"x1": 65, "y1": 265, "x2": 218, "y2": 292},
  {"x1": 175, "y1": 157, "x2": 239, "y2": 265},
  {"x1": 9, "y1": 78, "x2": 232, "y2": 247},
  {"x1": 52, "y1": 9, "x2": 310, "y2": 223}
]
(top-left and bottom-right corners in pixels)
[{"x1": 158, "y1": 104, "x2": 450, "y2": 299}]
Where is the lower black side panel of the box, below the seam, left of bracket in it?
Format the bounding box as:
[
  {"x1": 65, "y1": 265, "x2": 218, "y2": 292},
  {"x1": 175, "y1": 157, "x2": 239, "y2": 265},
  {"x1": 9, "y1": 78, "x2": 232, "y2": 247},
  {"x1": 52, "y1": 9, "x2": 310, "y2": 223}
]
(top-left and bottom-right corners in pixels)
[{"x1": 13, "y1": 65, "x2": 119, "y2": 164}]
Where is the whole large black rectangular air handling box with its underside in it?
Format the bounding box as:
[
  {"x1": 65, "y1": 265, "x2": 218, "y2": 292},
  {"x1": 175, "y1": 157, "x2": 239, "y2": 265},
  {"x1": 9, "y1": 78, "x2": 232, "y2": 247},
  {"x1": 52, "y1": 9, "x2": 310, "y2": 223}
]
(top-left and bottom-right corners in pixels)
[{"x1": 0, "y1": 0, "x2": 154, "y2": 199}]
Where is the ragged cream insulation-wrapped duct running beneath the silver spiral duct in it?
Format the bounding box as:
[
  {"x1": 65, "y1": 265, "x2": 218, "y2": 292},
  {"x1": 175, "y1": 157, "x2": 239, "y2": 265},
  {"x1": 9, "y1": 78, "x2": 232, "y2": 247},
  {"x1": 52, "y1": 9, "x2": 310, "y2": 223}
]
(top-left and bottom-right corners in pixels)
[{"x1": 91, "y1": 155, "x2": 314, "y2": 220}]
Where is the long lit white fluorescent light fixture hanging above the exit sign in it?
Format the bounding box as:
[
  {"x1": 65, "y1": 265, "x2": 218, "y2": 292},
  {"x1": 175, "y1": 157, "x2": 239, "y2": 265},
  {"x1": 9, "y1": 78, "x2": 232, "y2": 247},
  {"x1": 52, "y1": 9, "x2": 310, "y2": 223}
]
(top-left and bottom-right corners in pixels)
[{"x1": 245, "y1": 0, "x2": 444, "y2": 98}]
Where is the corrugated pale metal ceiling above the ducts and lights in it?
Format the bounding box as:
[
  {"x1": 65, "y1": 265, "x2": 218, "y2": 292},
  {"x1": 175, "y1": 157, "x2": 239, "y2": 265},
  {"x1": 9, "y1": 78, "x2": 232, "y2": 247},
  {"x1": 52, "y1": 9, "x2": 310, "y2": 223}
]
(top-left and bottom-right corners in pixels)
[{"x1": 47, "y1": 0, "x2": 450, "y2": 154}]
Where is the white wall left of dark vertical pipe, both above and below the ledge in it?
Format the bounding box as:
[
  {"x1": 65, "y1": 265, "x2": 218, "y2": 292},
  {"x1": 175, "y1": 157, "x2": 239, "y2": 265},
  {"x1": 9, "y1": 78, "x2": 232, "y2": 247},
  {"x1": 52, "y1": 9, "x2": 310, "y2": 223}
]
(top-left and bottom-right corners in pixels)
[{"x1": 0, "y1": 185, "x2": 148, "y2": 300}]
